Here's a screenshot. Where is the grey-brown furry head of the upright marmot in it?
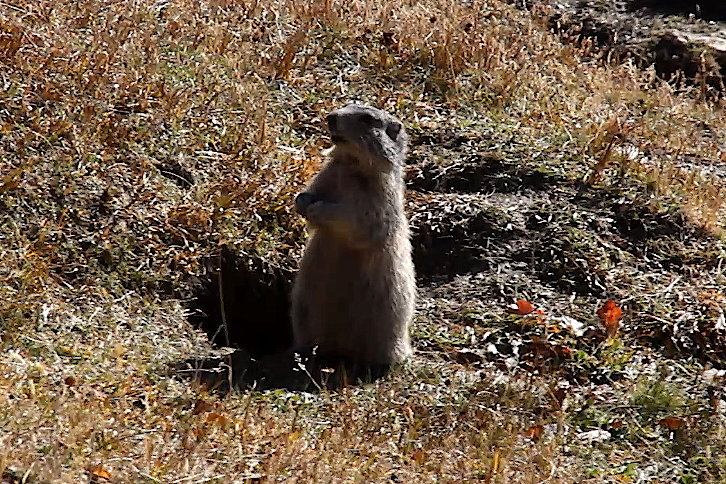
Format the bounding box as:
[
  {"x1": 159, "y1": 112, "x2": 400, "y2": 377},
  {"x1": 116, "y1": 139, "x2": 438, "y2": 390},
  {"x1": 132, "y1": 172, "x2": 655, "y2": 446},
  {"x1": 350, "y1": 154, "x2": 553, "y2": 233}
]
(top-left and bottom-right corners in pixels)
[{"x1": 328, "y1": 104, "x2": 408, "y2": 171}]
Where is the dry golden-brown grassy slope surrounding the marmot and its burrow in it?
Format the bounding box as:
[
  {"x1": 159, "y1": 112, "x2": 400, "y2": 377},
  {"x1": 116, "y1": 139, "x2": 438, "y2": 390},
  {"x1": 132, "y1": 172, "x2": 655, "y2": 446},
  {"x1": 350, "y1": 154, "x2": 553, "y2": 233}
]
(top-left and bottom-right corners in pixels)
[{"x1": 0, "y1": 0, "x2": 726, "y2": 483}]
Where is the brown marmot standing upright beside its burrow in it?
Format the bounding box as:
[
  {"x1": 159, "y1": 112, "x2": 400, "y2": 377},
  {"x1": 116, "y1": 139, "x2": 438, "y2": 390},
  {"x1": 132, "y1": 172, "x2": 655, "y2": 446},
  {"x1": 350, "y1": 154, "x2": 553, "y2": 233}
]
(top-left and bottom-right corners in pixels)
[{"x1": 291, "y1": 104, "x2": 416, "y2": 365}]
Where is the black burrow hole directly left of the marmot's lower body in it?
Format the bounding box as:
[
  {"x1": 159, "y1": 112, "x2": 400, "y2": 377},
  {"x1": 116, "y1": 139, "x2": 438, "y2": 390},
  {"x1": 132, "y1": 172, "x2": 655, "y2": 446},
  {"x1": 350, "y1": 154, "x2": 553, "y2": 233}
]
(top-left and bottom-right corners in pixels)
[{"x1": 189, "y1": 246, "x2": 293, "y2": 358}]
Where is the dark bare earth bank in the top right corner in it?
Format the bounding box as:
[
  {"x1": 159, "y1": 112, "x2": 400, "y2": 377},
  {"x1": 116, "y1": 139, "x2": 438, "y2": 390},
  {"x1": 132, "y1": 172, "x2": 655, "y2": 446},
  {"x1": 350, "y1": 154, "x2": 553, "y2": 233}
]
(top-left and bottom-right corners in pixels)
[{"x1": 528, "y1": 0, "x2": 726, "y2": 99}]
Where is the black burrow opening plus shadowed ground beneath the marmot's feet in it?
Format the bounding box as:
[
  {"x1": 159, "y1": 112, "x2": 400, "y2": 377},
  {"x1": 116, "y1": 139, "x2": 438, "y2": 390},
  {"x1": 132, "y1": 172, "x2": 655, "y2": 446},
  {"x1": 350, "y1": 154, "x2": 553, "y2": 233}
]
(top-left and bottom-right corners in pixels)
[{"x1": 181, "y1": 246, "x2": 398, "y2": 393}]
